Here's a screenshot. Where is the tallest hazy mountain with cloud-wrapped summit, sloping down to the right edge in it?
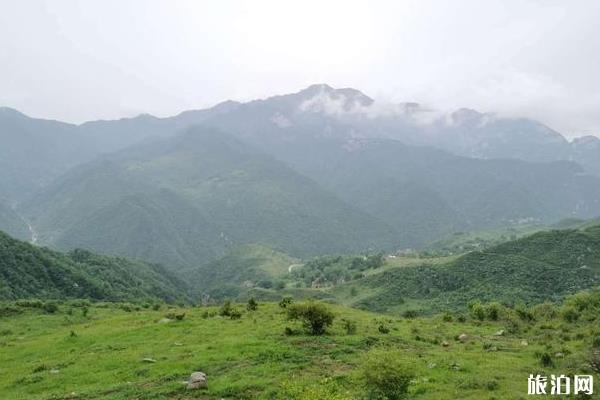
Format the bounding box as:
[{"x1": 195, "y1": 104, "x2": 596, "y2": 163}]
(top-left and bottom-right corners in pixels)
[{"x1": 189, "y1": 85, "x2": 600, "y2": 247}]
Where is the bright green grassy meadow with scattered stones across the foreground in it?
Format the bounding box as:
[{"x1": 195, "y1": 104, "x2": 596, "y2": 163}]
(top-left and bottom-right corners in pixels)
[{"x1": 0, "y1": 303, "x2": 600, "y2": 400}]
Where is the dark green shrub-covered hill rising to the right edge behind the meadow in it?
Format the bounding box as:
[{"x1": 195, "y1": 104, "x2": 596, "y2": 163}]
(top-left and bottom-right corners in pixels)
[{"x1": 358, "y1": 225, "x2": 600, "y2": 311}]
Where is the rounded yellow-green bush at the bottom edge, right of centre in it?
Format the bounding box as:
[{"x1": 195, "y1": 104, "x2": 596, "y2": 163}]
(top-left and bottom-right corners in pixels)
[{"x1": 361, "y1": 350, "x2": 414, "y2": 400}]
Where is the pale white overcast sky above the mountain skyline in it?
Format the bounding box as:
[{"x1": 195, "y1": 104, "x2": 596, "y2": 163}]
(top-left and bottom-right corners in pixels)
[{"x1": 0, "y1": 0, "x2": 600, "y2": 136}]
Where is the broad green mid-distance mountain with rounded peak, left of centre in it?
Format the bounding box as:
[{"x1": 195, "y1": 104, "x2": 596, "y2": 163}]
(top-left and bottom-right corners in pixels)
[{"x1": 22, "y1": 128, "x2": 394, "y2": 266}]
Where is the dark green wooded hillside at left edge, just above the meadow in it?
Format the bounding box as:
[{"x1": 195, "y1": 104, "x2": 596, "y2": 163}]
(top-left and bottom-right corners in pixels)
[{"x1": 0, "y1": 232, "x2": 187, "y2": 301}]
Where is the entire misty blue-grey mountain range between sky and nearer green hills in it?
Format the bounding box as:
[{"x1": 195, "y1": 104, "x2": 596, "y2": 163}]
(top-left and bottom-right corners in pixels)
[{"x1": 0, "y1": 85, "x2": 600, "y2": 268}]
